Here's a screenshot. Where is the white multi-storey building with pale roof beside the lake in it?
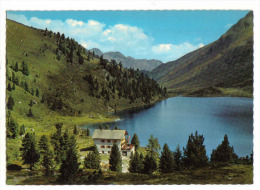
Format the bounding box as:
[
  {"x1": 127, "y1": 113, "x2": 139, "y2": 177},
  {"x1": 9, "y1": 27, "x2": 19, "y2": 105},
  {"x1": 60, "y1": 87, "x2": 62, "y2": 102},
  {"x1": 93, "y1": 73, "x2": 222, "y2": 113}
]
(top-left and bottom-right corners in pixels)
[{"x1": 92, "y1": 129, "x2": 135, "y2": 156}]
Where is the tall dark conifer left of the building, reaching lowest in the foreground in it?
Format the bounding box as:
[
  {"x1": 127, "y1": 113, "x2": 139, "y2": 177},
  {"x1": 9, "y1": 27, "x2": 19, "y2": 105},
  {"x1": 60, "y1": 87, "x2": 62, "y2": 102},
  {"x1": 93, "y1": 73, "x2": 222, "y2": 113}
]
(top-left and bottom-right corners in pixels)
[{"x1": 59, "y1": 135, "x2": 80, "y2": 183}]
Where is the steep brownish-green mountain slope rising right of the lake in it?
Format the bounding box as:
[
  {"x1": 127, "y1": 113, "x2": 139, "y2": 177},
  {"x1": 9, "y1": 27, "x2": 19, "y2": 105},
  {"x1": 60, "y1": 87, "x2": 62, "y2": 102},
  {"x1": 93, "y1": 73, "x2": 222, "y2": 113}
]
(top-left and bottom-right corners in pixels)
[{"x1": 151, "y1": 12, "x2": 253, "y2": 97}]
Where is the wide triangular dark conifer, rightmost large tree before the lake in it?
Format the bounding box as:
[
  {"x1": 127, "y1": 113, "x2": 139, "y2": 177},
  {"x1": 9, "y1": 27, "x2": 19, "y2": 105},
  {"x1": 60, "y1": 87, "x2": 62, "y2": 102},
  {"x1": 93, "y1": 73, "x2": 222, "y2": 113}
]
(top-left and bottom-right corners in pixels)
[{"x1": 210, "y1": 135, "x2": 238, "y2": 163}]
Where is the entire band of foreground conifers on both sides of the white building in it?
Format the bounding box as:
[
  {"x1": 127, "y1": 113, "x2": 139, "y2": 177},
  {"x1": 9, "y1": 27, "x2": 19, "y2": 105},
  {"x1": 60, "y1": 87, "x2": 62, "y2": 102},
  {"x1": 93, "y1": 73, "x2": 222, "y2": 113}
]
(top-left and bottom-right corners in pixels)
[{"x1": 10, "y1": 124, "x2": 253, "y2": 184}]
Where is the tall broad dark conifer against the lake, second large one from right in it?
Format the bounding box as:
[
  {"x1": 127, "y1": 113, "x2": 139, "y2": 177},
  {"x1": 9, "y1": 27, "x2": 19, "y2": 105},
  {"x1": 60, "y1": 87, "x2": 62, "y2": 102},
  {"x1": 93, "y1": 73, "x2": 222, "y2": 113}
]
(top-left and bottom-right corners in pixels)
[{"x1": 183, "y1": 131, "x2": 208, "y2": 168}]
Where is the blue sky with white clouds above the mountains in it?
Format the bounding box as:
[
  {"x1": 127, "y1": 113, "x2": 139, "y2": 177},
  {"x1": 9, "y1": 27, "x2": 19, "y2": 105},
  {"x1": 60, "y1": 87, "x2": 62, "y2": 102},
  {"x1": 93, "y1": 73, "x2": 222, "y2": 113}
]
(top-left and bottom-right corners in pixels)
[{"x1": 7, "y1": 10, "x2": 249, "y2": 62}]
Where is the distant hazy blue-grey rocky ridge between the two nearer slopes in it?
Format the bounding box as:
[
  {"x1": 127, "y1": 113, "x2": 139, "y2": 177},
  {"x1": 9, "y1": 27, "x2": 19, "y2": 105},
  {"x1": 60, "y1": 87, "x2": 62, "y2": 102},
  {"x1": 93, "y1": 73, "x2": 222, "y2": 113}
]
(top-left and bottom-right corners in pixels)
[{"x1": 90, "y1": 48, "x2": 163, "y2": 71}]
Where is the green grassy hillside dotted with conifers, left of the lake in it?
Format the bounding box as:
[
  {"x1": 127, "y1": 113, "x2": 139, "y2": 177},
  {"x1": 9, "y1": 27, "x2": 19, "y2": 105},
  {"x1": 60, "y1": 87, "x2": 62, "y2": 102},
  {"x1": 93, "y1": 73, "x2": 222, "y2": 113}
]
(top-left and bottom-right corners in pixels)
[{"x1": 6, "y1": 20, "x2": 165, "y2": 163}]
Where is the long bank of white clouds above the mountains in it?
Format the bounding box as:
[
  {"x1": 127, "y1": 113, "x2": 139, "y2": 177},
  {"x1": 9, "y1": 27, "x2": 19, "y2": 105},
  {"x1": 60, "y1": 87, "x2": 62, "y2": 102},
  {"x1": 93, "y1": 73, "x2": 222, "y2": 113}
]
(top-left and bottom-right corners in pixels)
[{"x1": 7, "y1": 13, "x2": 204, "y2": 62}]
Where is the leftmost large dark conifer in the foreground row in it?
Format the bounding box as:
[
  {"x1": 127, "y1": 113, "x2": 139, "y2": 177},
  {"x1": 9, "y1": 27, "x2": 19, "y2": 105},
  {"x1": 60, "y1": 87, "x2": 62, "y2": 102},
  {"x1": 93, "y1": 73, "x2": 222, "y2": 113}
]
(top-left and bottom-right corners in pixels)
[{"x1": 21, "y1": 133, "x2": 40, "y2": 170}]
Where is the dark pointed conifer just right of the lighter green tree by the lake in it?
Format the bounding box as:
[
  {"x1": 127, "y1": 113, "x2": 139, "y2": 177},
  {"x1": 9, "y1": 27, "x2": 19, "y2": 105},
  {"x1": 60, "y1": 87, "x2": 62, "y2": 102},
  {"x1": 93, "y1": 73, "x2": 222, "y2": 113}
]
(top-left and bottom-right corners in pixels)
[{"x1": 159, "y1": 144, "x2": 174, "y2": 173}]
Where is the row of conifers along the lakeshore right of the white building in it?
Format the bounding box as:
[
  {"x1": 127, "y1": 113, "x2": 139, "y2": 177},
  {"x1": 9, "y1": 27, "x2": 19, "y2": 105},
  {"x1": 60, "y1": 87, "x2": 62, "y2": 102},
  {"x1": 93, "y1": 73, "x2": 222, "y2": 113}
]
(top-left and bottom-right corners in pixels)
[{"x1": 129, "y1": 131, "x2": 253, "y2": 174}]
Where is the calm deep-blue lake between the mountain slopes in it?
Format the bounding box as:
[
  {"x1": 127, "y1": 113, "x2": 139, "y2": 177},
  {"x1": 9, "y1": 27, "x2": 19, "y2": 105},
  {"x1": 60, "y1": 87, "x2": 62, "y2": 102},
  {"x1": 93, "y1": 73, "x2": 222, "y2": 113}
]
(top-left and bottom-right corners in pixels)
[{"x1": 82, "y1": 97, "x2": 253, "y2": 156}]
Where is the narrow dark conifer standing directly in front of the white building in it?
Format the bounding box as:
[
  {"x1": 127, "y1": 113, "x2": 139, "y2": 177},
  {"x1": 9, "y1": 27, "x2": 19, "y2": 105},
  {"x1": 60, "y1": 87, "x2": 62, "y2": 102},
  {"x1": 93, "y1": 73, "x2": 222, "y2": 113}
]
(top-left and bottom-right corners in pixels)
[{"x1": 109, "y1": 143, "x2": 122, "y2": 172}]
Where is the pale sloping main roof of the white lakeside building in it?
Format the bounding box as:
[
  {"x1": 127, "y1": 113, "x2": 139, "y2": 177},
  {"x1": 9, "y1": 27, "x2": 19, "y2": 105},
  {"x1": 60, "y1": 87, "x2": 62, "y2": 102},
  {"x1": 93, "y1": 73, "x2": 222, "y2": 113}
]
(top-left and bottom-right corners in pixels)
[{"x1": 92, "y1": 129, "x2": 127, "y2": 139}]
